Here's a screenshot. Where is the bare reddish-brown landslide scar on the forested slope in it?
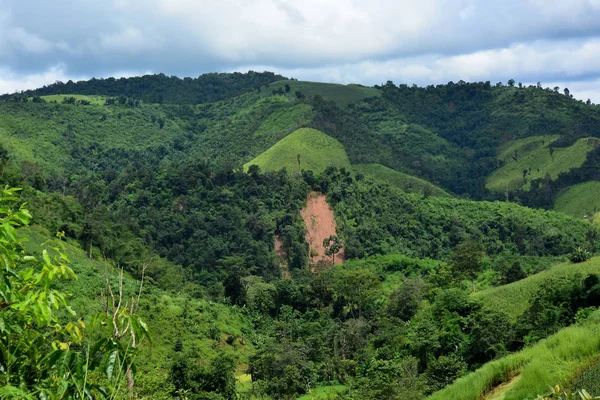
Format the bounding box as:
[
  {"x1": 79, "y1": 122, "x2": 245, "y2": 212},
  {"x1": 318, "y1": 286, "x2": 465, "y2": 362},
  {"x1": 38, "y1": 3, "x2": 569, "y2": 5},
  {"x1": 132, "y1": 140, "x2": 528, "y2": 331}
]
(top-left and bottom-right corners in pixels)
[{"x1": 300, "y1": 192, "x2": 344, "y2": 264}]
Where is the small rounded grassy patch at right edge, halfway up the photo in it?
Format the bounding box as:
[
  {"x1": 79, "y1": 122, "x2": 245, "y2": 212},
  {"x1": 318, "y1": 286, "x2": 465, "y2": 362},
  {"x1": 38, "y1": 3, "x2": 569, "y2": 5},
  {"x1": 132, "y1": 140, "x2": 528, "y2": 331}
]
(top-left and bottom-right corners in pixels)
[{"x1": 554, "y1": 181, "x2": 600, "y2": 222}]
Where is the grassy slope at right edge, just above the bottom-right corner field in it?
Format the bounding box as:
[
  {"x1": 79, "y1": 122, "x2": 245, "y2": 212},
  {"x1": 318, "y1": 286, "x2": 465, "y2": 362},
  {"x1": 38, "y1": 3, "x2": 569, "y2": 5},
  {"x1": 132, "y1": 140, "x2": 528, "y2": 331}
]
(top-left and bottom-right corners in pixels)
[{"x1": 474, "y1": 257, "x2": 600, "y2": 321}]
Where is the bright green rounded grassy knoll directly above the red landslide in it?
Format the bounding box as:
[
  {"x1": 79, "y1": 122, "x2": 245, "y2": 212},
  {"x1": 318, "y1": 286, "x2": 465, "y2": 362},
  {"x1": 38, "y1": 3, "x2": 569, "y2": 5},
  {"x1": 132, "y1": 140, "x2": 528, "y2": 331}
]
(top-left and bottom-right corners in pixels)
[{"x1": 244, "y1": 128, "x2": 350, "y2": 173}]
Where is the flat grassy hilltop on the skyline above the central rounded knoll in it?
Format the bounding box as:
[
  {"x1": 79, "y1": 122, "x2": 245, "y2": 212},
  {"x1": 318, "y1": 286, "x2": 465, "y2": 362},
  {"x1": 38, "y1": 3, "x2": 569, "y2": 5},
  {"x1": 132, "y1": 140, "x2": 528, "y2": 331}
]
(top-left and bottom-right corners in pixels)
[{"x1": 261, "y1": 80, "x2": 381, "y2": 107}]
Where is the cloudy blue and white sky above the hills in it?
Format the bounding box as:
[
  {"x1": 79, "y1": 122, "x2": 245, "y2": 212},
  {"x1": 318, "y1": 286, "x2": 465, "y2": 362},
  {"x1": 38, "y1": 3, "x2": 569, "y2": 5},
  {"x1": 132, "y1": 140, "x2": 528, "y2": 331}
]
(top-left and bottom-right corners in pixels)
[{"x1": 0, "y1": 0, "x2": 600, "y2": 103}]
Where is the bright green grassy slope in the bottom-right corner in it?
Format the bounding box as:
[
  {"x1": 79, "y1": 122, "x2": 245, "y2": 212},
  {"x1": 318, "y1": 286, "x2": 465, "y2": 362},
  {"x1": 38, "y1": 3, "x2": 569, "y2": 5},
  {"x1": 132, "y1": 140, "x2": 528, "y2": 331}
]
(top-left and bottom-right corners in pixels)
[{"x1": 428, "y1": 311, "x2": 600, "y2": 400}]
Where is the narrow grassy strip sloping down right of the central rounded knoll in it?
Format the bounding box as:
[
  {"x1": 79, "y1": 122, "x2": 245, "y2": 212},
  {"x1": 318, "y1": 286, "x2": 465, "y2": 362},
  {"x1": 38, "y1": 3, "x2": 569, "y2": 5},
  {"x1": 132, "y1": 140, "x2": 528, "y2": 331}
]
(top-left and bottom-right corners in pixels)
[{"x1": 353, "y1": 164, "x2": 450, "y2": 196}]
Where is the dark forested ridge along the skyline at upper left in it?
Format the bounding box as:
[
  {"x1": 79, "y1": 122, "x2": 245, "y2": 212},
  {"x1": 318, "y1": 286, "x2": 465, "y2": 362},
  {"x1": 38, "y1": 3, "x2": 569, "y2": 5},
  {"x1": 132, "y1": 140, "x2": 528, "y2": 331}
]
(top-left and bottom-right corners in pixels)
[{"x1": 0, "y1": 71, "x2": 286, "y2": 104}]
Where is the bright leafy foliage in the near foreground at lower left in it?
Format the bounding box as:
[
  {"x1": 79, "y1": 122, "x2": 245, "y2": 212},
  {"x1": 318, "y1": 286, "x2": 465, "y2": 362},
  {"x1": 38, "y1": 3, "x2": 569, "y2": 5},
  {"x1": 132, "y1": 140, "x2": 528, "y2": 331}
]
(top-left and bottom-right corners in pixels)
[{"x1": 0, "y1": 187, "x2": 148, "y2": 399}]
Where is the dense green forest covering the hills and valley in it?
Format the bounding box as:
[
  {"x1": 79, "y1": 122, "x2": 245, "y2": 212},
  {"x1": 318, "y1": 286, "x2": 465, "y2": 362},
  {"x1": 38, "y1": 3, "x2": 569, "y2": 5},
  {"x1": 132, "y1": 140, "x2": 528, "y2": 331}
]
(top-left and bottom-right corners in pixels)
[{"x1": 0, "y1": 72, "x2": 600, "y2": 400}]
